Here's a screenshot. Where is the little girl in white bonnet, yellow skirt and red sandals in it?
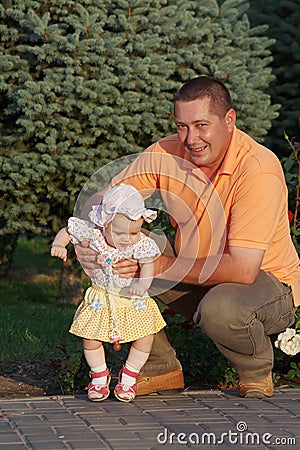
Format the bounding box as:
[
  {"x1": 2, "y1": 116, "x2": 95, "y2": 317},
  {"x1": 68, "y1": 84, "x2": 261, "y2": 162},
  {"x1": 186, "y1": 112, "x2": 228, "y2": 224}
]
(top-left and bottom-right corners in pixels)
[{"x1": 51, "y1": 184, "x2": 166, "y2": 402}]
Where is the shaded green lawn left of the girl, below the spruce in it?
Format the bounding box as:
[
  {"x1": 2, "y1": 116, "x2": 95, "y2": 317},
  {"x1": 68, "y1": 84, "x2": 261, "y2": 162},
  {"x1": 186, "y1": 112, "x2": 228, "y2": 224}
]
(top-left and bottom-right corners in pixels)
[{"x1": 0, "y1": 238, "x2": 81, "y2": 362}]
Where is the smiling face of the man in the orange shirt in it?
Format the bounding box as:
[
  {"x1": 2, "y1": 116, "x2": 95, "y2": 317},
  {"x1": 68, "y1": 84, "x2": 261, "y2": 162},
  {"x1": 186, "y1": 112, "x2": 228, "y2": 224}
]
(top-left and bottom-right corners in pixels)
[{"x1": 175, "y1": 97, "x2": 236, "y2": 176}]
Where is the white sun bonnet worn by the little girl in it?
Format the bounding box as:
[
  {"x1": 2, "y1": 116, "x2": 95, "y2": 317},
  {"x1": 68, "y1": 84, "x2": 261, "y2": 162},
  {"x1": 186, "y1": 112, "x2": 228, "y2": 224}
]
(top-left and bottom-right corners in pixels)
[{"x1": 89, "y1": 183, "x2": 157, "y2": 227}]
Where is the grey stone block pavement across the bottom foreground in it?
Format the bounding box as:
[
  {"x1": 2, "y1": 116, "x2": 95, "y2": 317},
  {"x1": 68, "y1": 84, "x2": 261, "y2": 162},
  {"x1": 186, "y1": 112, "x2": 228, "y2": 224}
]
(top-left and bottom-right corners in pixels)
[{"x1": 0, "y1": 389, "x2": 300, "y2": 450}]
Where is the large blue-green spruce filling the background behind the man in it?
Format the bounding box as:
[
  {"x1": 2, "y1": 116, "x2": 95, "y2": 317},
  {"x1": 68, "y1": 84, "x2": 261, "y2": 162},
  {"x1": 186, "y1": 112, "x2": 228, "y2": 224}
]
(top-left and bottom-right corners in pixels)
[{"x1": 0, "y1": 0, "x2": 278, "y2": 243}]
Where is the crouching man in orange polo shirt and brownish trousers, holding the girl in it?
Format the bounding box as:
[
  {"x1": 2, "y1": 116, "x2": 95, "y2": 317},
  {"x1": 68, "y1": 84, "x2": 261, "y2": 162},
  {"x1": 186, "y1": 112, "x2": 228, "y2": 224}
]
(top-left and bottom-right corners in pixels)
[{"x1": 77, "y1": 76, "x2": 300, "y2": 398}]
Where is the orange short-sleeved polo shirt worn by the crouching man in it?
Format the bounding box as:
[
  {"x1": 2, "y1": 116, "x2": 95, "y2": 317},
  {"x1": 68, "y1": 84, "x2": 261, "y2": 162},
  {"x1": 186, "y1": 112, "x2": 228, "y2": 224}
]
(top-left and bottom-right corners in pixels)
[{"x1": 113, "y1": 129, "x2": 300, "y2": 305}]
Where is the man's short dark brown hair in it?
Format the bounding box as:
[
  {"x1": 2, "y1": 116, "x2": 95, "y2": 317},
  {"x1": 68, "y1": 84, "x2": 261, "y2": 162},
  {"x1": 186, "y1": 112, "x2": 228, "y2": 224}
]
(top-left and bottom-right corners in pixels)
[{"x1": 174, "y1": 75, "x2": 233, "y2": 117}]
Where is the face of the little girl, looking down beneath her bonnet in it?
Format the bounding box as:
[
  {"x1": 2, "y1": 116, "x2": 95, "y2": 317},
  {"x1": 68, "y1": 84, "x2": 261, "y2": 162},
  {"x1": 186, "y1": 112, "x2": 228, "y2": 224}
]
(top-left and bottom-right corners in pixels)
[{"x1": 105, "y1": 214, "x2": 143, "y2": 250}]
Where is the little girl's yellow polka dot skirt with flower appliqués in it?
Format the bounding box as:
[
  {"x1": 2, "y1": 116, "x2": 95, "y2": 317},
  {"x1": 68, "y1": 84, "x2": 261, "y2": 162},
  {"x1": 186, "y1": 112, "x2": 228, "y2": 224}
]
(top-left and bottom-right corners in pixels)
[{"x1": 70, "y1": 285, "x2": 166, "y2": 343}]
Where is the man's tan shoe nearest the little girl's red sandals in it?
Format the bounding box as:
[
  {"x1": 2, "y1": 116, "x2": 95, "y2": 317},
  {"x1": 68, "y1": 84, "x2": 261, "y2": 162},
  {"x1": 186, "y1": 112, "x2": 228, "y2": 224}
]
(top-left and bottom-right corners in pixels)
[{"x1": 136, "y1": 369, "x2": 184, "y2": 395}]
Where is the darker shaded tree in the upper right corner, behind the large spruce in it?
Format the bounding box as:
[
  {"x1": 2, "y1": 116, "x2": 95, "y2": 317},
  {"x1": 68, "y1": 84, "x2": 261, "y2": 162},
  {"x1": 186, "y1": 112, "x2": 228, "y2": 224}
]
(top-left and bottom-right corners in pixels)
[{"x1": 248, "y1": 0, "x2": 300, "y2": 156}]
